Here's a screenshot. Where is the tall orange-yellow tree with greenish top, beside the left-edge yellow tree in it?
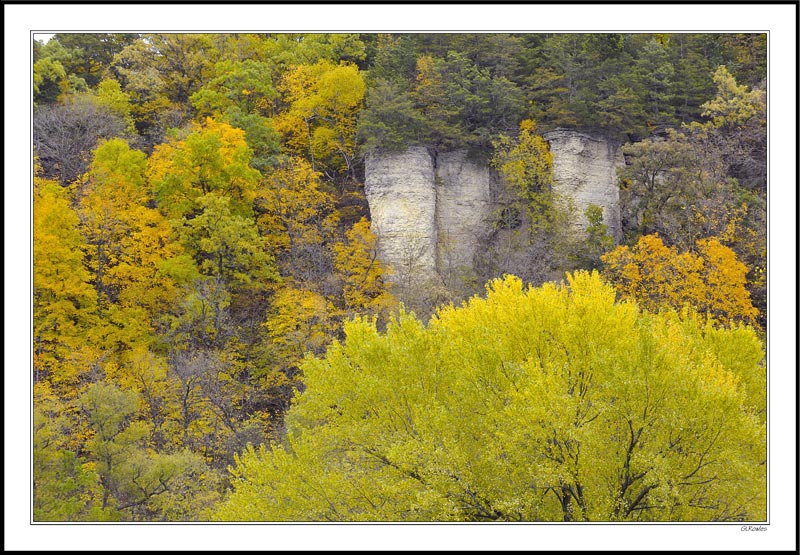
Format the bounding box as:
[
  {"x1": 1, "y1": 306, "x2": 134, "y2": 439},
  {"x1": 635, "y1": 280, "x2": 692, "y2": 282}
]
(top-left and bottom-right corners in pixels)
[{"x1": 79, "y1": 139, "x2": 183, "y2": 346}]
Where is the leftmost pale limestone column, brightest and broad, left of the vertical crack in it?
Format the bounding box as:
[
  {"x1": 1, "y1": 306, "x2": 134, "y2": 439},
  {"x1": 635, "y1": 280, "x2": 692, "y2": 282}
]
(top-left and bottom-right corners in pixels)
[{"x1": 364, "y1": 147, "x2": 437, "y2": 284}]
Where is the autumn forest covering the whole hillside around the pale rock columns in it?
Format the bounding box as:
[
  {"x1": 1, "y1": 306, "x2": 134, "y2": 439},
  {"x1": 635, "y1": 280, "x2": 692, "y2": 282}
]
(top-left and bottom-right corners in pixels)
[{"x1": 31, "y1": 33, "x2": 768, "y2": 521}]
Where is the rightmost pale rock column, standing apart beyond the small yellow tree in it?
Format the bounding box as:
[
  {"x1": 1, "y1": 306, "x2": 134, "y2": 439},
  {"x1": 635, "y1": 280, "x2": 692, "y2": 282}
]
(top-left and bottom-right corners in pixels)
[{"x1": 542, "y1": 129, "x2": 625, "y2": 240}]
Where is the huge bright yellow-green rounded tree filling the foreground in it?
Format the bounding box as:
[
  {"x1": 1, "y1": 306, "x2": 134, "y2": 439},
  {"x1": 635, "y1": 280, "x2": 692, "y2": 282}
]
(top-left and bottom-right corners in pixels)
[{"x1": 216, "y1": 272, "x2": 766, "y2": 522}]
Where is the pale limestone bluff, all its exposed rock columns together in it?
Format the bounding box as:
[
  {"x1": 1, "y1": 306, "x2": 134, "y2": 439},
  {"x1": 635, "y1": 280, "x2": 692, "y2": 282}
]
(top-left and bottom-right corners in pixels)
[{"x1": 365, "y1": 128, "x2": 624, "y2": 281}]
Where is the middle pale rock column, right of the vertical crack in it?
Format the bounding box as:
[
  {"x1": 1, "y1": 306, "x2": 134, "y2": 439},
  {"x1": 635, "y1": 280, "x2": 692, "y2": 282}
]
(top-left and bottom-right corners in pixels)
[{"x1": 435, "y1": 151, "x2": 493, "y2": 274}]
